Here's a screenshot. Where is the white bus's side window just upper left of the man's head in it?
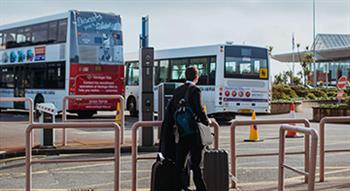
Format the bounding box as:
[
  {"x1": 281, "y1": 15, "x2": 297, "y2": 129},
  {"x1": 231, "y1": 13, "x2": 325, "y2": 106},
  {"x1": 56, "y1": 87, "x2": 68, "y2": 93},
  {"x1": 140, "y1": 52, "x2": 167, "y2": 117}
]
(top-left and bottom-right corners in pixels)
[{"x1": 170, "y1": 59, "x2": 188, "y2": 82}]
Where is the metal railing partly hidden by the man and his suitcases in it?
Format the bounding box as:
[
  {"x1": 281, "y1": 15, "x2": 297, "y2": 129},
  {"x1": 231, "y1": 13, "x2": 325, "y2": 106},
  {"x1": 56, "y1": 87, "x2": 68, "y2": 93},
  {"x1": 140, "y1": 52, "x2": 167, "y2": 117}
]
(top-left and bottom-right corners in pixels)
[{"x1": 131, "y1": 119, "x2": 219, "y2": 191}]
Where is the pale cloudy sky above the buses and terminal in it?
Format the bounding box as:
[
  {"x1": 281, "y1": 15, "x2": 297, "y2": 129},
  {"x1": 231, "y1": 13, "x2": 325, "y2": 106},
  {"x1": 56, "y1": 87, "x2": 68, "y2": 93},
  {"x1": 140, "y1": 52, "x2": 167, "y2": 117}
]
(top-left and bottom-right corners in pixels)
[{"x1": 0, "y1": 0, "x2": 350, "y2": 75}]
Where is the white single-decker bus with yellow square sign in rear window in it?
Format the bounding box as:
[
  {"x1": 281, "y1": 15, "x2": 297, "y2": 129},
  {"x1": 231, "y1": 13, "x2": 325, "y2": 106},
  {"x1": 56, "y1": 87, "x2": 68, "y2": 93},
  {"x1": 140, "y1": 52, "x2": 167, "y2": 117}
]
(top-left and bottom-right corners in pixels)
[{"x1": 125, "y1": 44, "x2": 271, "y2": 120}]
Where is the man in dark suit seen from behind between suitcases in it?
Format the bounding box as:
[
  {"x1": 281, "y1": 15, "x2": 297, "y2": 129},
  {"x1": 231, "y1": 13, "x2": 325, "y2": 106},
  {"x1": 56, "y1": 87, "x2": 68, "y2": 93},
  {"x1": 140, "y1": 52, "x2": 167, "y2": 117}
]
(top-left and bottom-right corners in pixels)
[{"x1": 169, "y1": 67, "x2": 211, "y2": 191}]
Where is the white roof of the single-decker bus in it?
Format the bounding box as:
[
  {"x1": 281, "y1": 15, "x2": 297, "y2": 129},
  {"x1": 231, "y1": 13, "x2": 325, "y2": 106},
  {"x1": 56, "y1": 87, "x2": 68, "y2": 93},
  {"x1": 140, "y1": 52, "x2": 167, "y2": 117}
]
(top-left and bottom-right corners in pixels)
[{"x1": 125, "y1": 44, "x2": 266, "y2": 61}]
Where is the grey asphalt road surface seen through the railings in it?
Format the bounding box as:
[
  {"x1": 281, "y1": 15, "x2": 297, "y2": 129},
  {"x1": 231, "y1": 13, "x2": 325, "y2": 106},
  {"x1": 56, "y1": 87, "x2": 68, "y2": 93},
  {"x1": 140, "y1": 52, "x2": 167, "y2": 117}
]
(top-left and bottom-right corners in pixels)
[{"x1": 0, "y1": 109, "x2": 350, "y2": 191}]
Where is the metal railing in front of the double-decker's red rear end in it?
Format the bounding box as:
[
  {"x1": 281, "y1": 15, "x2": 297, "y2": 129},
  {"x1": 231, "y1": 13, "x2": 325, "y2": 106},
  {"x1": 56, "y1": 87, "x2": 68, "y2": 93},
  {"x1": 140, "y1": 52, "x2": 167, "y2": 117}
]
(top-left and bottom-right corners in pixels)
[{"x1": 62, "y1": 95, "x2": 125, "y2": 146}]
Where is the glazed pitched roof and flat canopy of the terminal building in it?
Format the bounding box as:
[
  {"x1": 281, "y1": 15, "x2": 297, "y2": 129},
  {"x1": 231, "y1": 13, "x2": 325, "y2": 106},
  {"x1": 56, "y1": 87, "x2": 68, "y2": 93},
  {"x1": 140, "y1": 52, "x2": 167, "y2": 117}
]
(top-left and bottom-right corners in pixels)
[{"x1": 272, "y1": 34, "x2": 350, "y2": 62}]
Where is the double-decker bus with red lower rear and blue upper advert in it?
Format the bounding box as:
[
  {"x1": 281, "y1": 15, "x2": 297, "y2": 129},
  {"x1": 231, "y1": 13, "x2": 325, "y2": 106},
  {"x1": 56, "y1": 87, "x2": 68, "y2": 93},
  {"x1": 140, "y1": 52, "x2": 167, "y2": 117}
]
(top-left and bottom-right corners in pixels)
[{"x1": 0, "y1": 10, "x2": 125, "y2": 116}]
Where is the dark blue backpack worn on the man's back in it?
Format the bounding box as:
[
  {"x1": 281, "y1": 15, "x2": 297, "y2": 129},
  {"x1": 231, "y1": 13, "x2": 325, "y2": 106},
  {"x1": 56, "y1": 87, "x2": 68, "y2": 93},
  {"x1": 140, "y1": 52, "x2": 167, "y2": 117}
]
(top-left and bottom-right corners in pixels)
[{"x1": 174, "y1": 85, "x2": 196, "y2": 137}]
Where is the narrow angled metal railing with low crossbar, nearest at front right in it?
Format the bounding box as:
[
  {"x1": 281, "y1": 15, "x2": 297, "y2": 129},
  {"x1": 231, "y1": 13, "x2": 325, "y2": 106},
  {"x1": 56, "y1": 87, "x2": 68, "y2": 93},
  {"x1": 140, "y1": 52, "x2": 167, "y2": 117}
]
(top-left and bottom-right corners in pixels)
[{"x1": 278, "y1": 125, "x2": 318, "y2": 191}]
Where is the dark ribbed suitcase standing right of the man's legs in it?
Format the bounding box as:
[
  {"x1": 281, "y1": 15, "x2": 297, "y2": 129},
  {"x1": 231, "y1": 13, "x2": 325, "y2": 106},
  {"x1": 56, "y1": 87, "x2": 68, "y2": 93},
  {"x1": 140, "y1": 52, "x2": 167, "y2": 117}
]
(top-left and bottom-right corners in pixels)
[{"x1": 203, "y1": 149, "x2": 229, "y2": 191}]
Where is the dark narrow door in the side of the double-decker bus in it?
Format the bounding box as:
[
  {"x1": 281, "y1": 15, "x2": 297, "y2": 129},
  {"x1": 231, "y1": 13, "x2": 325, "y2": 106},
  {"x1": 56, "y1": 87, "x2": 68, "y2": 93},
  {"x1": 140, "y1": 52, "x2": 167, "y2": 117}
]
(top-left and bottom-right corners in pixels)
[{"x1": 14, "y1": 66, "x2": 26, "y2": 109}]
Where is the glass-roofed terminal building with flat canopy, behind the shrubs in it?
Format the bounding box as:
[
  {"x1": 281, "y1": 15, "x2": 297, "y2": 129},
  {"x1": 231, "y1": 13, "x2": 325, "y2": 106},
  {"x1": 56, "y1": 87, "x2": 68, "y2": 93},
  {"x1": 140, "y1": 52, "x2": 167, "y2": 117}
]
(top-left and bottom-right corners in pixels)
[{"x1": 272, "y1": 34, "x2": 350, "y2": 86}]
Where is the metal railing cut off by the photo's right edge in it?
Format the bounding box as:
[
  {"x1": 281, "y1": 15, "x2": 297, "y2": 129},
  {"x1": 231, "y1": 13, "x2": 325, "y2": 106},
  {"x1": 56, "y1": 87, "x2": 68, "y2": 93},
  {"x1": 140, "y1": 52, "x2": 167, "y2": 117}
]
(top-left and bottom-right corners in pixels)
[{"x1": 320, "y1": 117, "x2": 350, "y2": 182}]
